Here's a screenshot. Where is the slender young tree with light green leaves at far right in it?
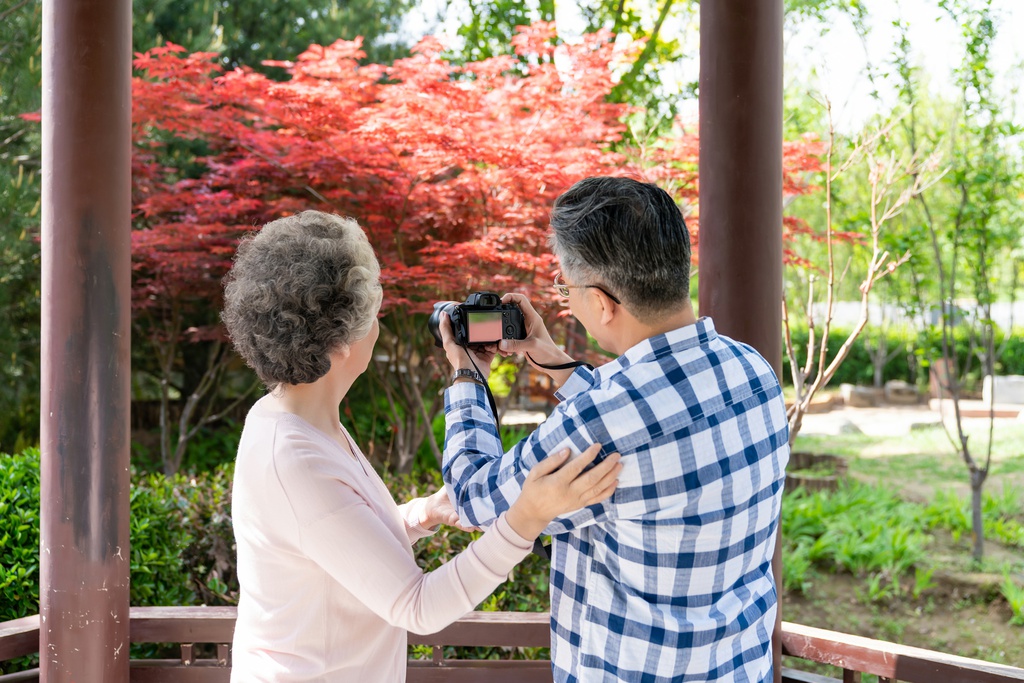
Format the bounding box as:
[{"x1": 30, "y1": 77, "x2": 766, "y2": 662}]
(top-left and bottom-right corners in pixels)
[{"x1": 876, "y1": 0, "x2": 1022, "y2": 561}]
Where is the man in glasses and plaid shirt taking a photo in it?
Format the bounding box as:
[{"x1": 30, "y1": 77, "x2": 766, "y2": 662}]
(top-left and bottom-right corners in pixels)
[{"x1": 441, "y1": 177, "x2": 788, "y2": 683}]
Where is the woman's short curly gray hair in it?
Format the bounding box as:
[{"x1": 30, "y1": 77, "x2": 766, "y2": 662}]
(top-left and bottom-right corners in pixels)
[{"x1": 221, "y1": 211, "x2": 382, "y2": 391}]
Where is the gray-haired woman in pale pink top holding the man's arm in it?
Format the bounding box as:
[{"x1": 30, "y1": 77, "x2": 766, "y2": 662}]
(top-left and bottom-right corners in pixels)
[{"x1": 223, "y1": 211, "x2": 621, "y2": 682}]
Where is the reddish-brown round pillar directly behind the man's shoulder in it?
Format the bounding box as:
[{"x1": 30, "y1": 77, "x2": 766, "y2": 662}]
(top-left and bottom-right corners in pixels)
[{"x1": 698, "y1": 0, "x2": 782, "y2": 681}]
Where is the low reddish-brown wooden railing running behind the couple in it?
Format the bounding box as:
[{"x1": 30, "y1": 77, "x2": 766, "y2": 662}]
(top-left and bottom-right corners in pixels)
[{"x1": 0, "y1": 607, "x2": 1024, "y2": 683}]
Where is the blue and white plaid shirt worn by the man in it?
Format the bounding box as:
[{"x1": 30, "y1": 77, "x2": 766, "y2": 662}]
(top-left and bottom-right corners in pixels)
[{"x1": 443, "y1": 318, "x2": 790, "y2": 683}]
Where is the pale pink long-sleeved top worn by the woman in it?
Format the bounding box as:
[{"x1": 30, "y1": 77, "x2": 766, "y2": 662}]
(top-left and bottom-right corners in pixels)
[{"x1": 231, "y1": 400, "x2": 532, "y2": 683}]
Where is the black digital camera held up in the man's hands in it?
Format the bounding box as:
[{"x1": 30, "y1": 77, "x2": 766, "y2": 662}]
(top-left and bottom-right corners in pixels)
[{"x1": 427, "y1": 292, "x2": 526, "y2": 347}]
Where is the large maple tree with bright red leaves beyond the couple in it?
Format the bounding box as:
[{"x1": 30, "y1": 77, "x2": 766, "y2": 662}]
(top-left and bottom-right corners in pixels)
[{"x1": 133, "y1": 23, "x2": 819, "y2": 470}]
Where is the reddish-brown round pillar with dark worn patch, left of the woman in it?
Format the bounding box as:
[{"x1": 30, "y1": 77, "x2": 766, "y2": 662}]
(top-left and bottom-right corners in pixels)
[{"x1": 39, "y1": 0, "x2": 132, "y2": 683}]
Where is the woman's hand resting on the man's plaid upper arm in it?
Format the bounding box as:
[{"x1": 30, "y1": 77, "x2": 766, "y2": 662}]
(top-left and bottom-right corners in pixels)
[{"x1": 506, "y1": 443, "x2": 623, "y2": 540}]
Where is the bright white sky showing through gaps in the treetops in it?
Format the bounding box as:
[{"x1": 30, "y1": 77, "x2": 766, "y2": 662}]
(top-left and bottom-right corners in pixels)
[{"x1": 407, "y1": 0, "x2": 1024, "y2": 132}]
